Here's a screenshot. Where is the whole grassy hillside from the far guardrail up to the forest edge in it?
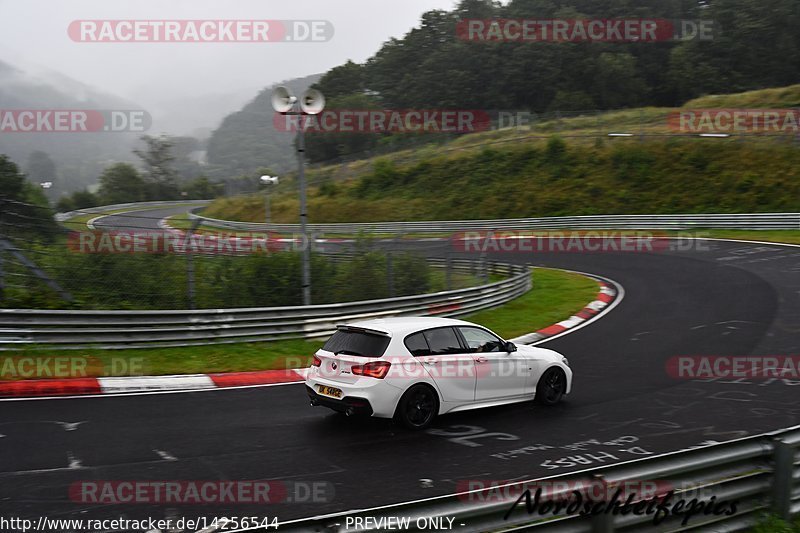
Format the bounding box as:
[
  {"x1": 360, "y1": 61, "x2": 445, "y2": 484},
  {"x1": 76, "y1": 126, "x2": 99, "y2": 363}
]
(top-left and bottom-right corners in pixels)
[{"x1": 206, "y1": 86, "x2": 800, "y2": 222}]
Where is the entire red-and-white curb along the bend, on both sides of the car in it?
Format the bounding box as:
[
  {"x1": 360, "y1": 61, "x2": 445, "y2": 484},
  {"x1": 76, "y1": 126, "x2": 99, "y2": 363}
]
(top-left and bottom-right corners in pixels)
[{"x1": 0, "y1": 274, "x2": 618, "y2": 398}]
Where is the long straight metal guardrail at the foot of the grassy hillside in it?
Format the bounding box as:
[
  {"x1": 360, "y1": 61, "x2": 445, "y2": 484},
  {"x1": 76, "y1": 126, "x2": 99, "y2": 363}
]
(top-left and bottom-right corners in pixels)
[{"x1": 190, "y1": 208, "x2": 800, "y2": 234}]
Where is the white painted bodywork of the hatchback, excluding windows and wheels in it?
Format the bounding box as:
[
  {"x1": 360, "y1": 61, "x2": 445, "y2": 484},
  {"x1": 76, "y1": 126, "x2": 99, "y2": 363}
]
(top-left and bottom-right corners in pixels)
[{"x1": 306, "y1": 317, "x2": 572, "y2": 418}]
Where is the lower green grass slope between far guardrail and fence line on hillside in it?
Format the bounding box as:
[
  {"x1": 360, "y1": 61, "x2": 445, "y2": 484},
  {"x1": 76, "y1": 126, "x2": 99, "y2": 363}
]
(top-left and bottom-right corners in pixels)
[{"x1": 206, "y1": 138, "x2": 800, "y2": 223}]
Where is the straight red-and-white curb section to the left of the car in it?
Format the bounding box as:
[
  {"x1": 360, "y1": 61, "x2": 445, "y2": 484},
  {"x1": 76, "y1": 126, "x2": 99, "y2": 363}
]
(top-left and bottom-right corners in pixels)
[{"x1": 0, "y1": 368, "x2": 306, "y2": 398}]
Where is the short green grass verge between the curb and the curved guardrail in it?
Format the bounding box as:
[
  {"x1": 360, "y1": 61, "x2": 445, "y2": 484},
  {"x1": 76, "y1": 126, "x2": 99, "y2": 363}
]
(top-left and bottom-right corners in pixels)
[{"x1": 0, "y1": 269, "x2": 597, "y2": 377}]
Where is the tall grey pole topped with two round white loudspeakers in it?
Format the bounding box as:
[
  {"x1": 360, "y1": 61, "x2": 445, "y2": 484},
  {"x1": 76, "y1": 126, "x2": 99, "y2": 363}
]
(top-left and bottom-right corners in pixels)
[{"x1": 272, "y1": 87, "x2": 325, "y2": 305}]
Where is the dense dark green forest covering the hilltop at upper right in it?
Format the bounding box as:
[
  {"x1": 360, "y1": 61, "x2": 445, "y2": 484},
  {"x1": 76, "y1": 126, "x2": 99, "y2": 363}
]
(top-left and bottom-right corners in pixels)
[{"x1": 296, "y1": 0, "x2": 800, "y2": 161}]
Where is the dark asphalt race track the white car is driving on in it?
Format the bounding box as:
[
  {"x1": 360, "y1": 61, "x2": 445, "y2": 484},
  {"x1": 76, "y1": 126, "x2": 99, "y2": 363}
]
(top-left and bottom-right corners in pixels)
[{"x1": 0, "y1": 209, "x2": 800, "y2": 521}]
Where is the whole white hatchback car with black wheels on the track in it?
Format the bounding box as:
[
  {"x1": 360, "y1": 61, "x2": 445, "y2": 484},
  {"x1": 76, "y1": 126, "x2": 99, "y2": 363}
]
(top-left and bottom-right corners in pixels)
[{"x1": 306, "y1": 318, "x2": 572, "y2": 429}]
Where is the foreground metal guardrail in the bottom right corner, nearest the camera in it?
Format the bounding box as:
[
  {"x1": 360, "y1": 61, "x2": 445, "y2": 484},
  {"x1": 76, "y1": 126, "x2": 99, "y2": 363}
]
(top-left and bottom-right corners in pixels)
[{"x1": 280, "y1": 426, "x2": 800, "y2": 533}]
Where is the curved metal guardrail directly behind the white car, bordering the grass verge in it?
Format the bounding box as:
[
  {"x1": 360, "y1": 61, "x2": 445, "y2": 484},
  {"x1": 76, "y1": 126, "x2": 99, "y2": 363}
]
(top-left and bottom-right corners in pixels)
[{"x1": 0, "y1": 260, "x2": 532, "y2": 350}]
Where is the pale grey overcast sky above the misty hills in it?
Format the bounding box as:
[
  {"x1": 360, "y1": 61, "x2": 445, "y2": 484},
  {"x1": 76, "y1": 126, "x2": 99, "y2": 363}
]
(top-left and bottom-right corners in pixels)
[{"x1": 0, "y1": 0, "x2": 456, "y2": 131}]
